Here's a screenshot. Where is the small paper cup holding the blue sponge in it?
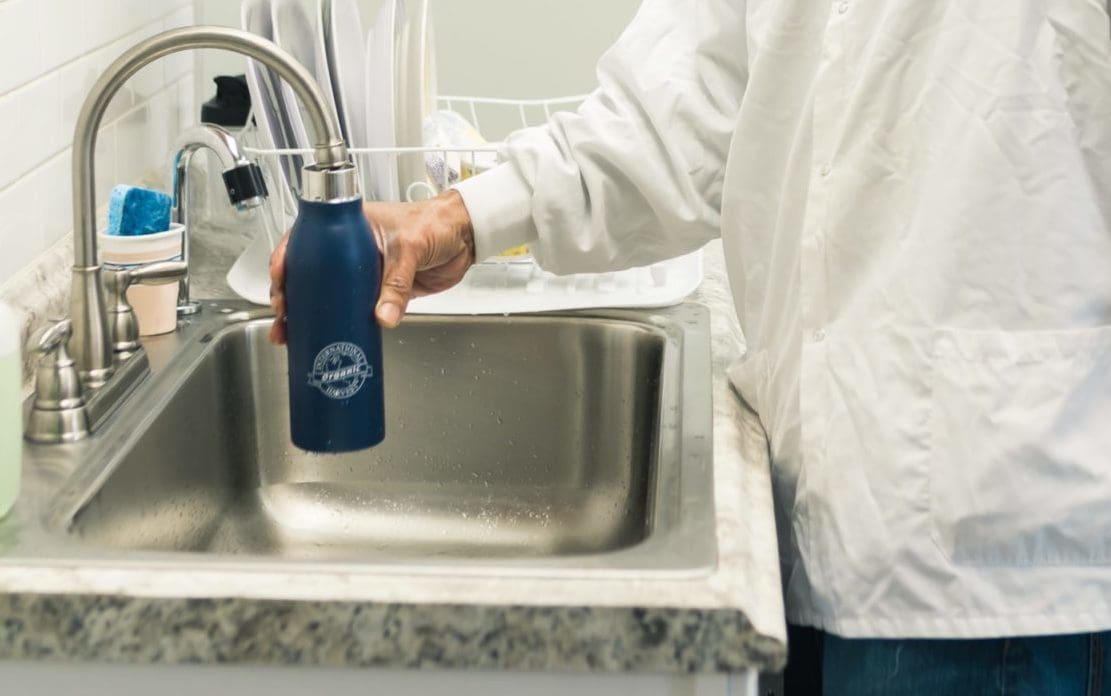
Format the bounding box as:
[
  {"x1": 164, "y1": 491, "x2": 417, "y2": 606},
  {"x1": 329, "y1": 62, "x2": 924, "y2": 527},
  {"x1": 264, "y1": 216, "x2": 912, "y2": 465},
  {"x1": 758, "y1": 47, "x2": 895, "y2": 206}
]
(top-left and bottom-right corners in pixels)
[{"x1": 98, "y1": 222, "x2": 186, "y2": 336}]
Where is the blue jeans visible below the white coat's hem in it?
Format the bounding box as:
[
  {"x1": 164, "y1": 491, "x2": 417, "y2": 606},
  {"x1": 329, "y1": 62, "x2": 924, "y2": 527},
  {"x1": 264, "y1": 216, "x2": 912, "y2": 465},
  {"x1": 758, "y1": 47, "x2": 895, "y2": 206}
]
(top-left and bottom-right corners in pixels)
[{"x1": 784, "y1": 626, "x2": 1111, "y2": 696}]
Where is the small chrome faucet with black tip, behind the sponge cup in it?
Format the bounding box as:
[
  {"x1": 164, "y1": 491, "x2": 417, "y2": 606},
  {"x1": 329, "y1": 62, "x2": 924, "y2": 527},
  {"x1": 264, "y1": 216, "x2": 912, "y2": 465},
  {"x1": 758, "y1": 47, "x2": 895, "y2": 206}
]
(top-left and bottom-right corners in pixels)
[{"x1": 173, "y1": 123, "x2": 267, "y2": 315}]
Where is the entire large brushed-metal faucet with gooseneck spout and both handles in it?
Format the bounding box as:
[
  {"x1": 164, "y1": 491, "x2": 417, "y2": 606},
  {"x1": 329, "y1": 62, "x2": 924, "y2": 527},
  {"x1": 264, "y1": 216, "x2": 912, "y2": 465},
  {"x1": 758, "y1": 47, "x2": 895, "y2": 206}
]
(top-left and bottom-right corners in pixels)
[{"x1": 27, "y1": 27, "x2": 357, "y2": 443}]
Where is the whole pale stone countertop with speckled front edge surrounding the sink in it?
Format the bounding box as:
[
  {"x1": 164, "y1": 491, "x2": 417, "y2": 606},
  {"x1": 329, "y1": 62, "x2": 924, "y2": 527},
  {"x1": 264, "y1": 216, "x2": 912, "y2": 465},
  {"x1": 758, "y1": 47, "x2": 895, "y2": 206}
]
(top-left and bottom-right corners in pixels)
[{"x1": 0, "y1": 217, "x2": 785, "y2": 673}]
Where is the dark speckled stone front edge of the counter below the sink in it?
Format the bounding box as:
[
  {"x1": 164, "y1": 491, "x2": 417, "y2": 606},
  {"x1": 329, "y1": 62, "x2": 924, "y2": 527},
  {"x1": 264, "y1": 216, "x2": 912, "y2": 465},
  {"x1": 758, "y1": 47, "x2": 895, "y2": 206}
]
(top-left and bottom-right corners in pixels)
[{"x1": 0, "y1": 595, "x2": 783, "y2": 673}]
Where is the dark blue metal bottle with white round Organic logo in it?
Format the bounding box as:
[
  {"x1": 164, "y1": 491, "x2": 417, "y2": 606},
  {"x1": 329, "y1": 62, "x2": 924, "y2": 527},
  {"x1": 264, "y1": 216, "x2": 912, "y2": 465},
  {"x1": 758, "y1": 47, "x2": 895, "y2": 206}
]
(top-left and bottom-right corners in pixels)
[{"x1": 286, "y1": 166, "x2": 386, "y2": 453}]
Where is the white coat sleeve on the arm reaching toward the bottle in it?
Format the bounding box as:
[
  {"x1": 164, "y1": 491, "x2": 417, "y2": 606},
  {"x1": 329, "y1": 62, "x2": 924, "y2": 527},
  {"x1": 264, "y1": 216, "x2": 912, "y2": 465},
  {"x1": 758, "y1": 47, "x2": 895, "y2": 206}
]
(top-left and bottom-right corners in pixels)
[{"x1": 456, "y1": 0, "x2": 748, "y2": 274}]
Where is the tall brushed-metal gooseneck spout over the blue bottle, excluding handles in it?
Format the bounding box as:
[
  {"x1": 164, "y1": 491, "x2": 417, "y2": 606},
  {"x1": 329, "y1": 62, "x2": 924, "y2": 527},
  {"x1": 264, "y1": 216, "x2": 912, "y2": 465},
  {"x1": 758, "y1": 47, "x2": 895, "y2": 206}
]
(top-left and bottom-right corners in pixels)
[{"x1": 70, "y1": 27, "x2": 354, "y2": 388}]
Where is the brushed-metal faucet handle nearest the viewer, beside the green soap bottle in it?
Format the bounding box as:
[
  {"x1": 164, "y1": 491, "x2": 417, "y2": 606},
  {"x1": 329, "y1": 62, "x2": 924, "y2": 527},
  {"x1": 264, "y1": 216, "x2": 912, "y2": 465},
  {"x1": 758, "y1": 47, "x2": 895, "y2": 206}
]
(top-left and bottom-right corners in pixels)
[{"x1": 27, "y1": 319, "x2": 89, "y2": 443}]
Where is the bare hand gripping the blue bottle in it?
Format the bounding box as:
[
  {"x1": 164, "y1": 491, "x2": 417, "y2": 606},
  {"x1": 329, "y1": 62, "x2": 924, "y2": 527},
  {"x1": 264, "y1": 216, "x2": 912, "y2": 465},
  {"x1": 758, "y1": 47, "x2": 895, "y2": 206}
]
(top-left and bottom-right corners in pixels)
[{"x1": 270, "y1": 189, "x2": 474, "y2": 345}]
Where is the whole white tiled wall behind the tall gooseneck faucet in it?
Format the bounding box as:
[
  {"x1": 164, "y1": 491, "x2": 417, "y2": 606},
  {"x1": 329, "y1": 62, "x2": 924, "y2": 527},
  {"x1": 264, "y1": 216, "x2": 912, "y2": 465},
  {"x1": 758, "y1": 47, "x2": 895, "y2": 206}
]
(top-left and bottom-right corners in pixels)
[{"x1": 0, "y1": 0, "x2": 197, "y2": 285}]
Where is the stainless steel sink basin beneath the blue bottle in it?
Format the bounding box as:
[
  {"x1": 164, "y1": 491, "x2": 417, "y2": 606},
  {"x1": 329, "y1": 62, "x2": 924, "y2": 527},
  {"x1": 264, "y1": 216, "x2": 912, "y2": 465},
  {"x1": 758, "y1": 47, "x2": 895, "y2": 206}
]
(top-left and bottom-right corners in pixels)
[{"x1": 49, "y1": 302, "x2": 715, "y2": 570}]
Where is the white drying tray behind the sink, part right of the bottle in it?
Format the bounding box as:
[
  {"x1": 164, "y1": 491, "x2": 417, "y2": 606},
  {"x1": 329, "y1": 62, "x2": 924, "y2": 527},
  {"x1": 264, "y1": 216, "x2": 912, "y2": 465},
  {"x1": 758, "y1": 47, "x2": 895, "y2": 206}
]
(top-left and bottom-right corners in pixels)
[{"x1": 408, "y1": 250, "x2": 702, "y2": 315}]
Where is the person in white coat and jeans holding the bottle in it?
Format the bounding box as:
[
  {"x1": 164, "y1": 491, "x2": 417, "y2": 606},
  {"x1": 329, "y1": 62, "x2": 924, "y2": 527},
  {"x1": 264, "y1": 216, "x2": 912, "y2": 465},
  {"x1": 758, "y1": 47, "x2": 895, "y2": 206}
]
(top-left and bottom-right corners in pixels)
[{"x1": 273, "y1": 0, "x2": 1111, "y2": 695}]
